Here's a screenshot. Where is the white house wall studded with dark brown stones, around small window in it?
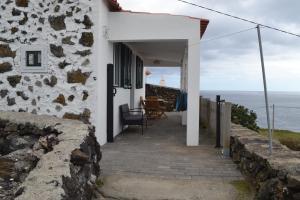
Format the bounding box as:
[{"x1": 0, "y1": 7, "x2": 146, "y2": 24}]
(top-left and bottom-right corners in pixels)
[{"x1": 0, "y1": 0, "x2": 96, "y2": 125}]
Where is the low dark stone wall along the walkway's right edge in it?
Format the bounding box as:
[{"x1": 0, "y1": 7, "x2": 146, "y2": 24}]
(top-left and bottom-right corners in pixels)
[{"x1": 230, "y1": 125, "x2": 300, "y2": 200}]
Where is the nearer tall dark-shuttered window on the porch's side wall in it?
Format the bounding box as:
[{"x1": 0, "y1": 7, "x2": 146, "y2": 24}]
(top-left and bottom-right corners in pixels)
[{"x1": 114, "y1": 43, "x2": 132, "y2": 89}]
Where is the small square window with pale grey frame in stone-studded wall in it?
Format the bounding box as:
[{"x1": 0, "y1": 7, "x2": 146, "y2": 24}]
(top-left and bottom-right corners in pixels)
[{"x1": 21, "y1": 45, "x2": 48, "y2": 73}]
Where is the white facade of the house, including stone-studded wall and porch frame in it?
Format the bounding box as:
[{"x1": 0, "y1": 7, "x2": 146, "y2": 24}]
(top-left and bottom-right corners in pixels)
[{"x1": 0, "y1": 0, "x2": 206, "y2": 146}]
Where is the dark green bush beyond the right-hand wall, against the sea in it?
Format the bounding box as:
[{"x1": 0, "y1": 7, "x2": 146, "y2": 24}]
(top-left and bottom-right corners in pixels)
[{"x1": 231, "y1": 104, "x2": 259, "y2": 132}]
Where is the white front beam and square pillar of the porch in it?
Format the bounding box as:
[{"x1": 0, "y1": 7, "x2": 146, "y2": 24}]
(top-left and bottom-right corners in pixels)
[{"x1": 108, "y1": 12, "x2": 200, "y2": 146}]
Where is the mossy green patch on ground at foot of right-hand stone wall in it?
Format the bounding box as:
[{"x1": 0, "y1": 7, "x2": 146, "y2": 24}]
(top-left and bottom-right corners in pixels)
[{"x1": 230, "y1": 180, "x2": 253, "y2": 200}]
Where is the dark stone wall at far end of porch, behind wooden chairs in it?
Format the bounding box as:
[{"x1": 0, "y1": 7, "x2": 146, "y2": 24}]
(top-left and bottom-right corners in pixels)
[{"x1": 146, "y1": 84, "x2": 180, "y2": 111}]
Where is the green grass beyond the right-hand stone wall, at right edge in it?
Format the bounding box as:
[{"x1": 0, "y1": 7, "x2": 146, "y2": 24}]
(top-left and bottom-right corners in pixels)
[{"x1": 259, "y1": 129, "x2": 300, "y2": 151}]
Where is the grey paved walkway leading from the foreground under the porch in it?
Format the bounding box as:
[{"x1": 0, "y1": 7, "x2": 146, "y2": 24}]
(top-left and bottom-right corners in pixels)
[{"x1": 96, "y1": 113, "x2": 253, "y2": 200}]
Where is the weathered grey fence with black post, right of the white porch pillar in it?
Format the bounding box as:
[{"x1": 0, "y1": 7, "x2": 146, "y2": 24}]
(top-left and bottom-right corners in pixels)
[{"x1": 200, "y1": 97, "x2": 231, "y2": 156}]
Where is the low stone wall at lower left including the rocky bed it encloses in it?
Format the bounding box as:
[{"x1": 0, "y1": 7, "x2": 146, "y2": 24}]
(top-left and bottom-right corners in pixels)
[{"x1": 0, "y1": 112, "x2": 101, "y2": 200}]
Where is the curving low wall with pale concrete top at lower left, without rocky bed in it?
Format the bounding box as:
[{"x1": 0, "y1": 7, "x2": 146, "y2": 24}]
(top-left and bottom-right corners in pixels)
[{"x1": 0, "y1": 112, "x2": 101, "y2": 200}]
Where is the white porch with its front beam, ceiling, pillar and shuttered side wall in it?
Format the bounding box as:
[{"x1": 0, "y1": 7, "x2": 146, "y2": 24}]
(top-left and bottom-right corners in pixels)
[{"x1": 105, "y1": 12, "x2": 208, "y2": 146}]
